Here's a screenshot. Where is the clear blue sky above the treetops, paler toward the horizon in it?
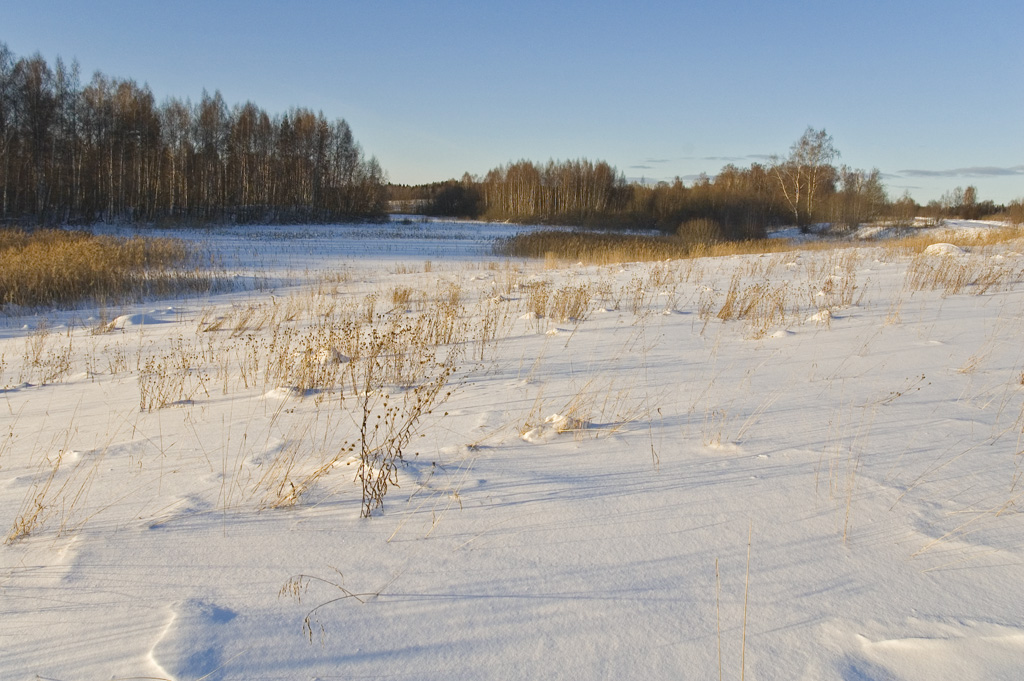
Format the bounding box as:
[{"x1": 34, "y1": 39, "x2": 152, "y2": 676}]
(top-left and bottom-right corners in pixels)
[{"x1": 0, "y1": 0, "x2": 1024, "y2": 202}]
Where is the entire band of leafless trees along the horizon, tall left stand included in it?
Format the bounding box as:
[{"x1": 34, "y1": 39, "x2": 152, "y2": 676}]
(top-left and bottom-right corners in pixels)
[{"x1": 0, "y1": 43, "x2": 1011, "y2": 233}]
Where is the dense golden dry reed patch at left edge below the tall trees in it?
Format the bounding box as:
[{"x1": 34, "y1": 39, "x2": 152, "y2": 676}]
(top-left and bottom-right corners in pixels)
[{"x1": 0, "y1": 229, "x2": 210, "y2": 307}]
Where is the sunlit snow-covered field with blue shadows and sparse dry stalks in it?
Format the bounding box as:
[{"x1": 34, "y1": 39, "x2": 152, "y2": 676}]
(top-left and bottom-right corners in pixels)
[{"x1": 0, "y1": 223, "x2": 1024, "y2": 681}]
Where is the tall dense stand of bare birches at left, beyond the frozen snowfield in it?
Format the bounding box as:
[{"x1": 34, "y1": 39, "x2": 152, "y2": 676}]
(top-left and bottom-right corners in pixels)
[{"x1": 0, "y1": 43, "x2": 387, "y2": 224}]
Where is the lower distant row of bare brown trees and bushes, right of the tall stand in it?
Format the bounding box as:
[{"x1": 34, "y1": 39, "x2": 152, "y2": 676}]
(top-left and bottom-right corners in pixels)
[{"x1": 399, "y1": 127, "x2": 1004, "y2": 240}]
